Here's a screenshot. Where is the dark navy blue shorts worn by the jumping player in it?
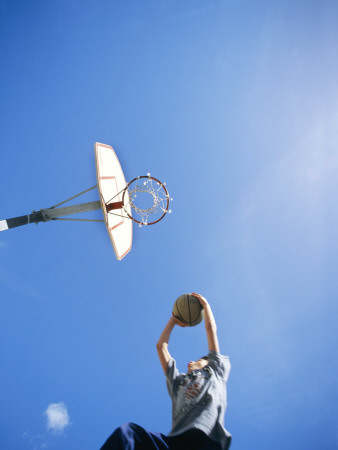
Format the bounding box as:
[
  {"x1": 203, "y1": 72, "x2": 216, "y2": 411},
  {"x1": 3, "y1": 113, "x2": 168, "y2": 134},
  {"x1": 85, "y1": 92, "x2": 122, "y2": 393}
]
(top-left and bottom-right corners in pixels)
[{"x1": 101, "y1": 423, "x2": 222, "y2": 450}]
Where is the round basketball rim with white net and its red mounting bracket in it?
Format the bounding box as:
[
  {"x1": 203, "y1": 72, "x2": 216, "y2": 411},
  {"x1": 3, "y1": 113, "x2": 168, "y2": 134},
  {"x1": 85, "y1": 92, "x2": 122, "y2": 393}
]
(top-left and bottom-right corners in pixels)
[{"x1": 106, "y1": 173, "x2": 172, "y2": 227}]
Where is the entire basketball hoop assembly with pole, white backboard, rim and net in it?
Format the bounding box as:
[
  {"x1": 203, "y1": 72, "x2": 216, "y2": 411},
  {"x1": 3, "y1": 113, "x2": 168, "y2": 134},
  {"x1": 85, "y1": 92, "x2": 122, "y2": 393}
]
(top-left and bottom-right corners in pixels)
[{"x1": 0, "y1": 142, "x2": 172, "y2": 260}]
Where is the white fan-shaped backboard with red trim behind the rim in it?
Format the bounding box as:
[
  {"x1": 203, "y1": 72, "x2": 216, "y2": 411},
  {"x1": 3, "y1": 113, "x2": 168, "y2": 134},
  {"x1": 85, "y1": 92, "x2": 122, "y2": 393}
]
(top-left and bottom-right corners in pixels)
[{"x1": 95, "y1": 142, "x2": 133, "y2": 260}]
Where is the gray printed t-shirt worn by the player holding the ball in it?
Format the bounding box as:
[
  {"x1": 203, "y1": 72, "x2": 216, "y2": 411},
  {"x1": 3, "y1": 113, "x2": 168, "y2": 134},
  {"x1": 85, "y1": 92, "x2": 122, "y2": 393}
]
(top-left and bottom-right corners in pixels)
[{"x1": 166, "y1": 350, "x2": 231, "y2": 449}]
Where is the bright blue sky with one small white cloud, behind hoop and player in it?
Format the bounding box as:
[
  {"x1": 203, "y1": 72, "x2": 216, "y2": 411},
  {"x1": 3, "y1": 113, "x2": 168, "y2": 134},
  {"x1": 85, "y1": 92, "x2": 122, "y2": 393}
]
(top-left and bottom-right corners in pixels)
[{"x1": 0, "y1": 0, "x2": 338, "y2": 450}]
